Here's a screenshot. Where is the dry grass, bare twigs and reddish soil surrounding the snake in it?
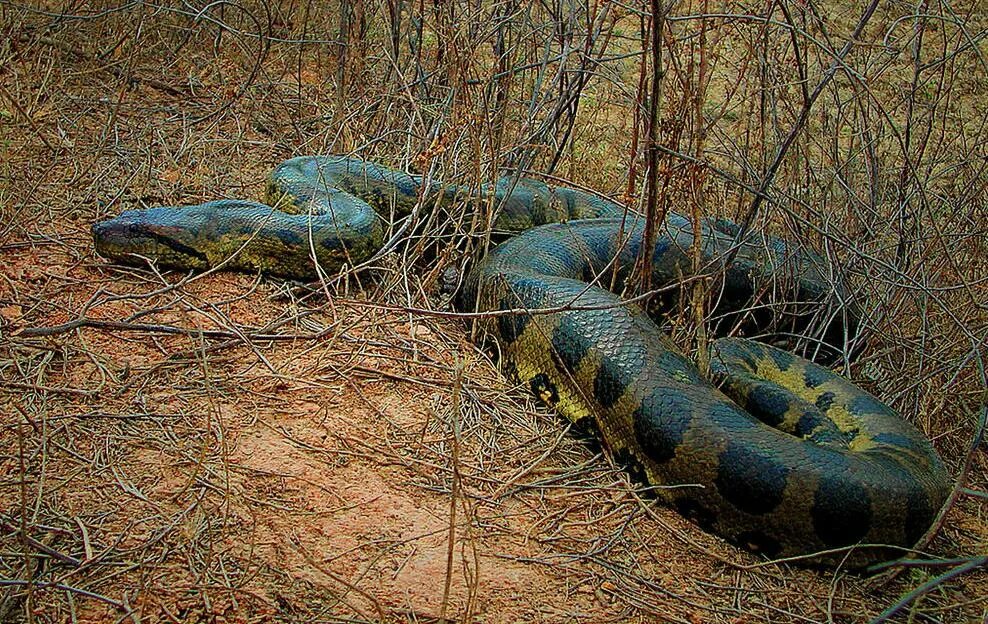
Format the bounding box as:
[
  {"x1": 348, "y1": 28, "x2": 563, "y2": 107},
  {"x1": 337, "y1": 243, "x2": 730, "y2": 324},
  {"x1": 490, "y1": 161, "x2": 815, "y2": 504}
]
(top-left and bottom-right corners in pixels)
[{"x1": 0, "y1": 1, "x2": 988, "y2": 623}]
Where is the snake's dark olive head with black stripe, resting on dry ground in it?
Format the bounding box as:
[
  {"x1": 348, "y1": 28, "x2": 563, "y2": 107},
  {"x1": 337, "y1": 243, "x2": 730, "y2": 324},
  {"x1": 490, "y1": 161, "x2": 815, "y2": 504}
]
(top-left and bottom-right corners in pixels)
[{"x1": 92, "y1": 207, "x2": 209, "y2": 270}]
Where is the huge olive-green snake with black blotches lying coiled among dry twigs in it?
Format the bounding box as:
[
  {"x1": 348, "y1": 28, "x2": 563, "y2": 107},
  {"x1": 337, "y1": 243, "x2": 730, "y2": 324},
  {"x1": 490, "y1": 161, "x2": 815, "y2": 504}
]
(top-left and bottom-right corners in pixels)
[{"x1": 93, "y1": 156, "x2": 949, "y2": 565}]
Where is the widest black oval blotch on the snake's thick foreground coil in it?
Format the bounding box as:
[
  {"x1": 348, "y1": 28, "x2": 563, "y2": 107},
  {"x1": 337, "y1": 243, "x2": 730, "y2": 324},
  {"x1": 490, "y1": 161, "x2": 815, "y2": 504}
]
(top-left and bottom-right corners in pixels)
[{"x1": 714, "y1": 442, "x2": 789, "y2": 515}]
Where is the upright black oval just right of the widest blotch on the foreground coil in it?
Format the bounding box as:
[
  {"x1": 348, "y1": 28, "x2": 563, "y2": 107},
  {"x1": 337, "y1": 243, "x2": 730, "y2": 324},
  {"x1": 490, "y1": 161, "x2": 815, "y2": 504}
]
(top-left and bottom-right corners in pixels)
[{"x1": 810, "y1": 471, "x2": 872, "y2": 548}]
